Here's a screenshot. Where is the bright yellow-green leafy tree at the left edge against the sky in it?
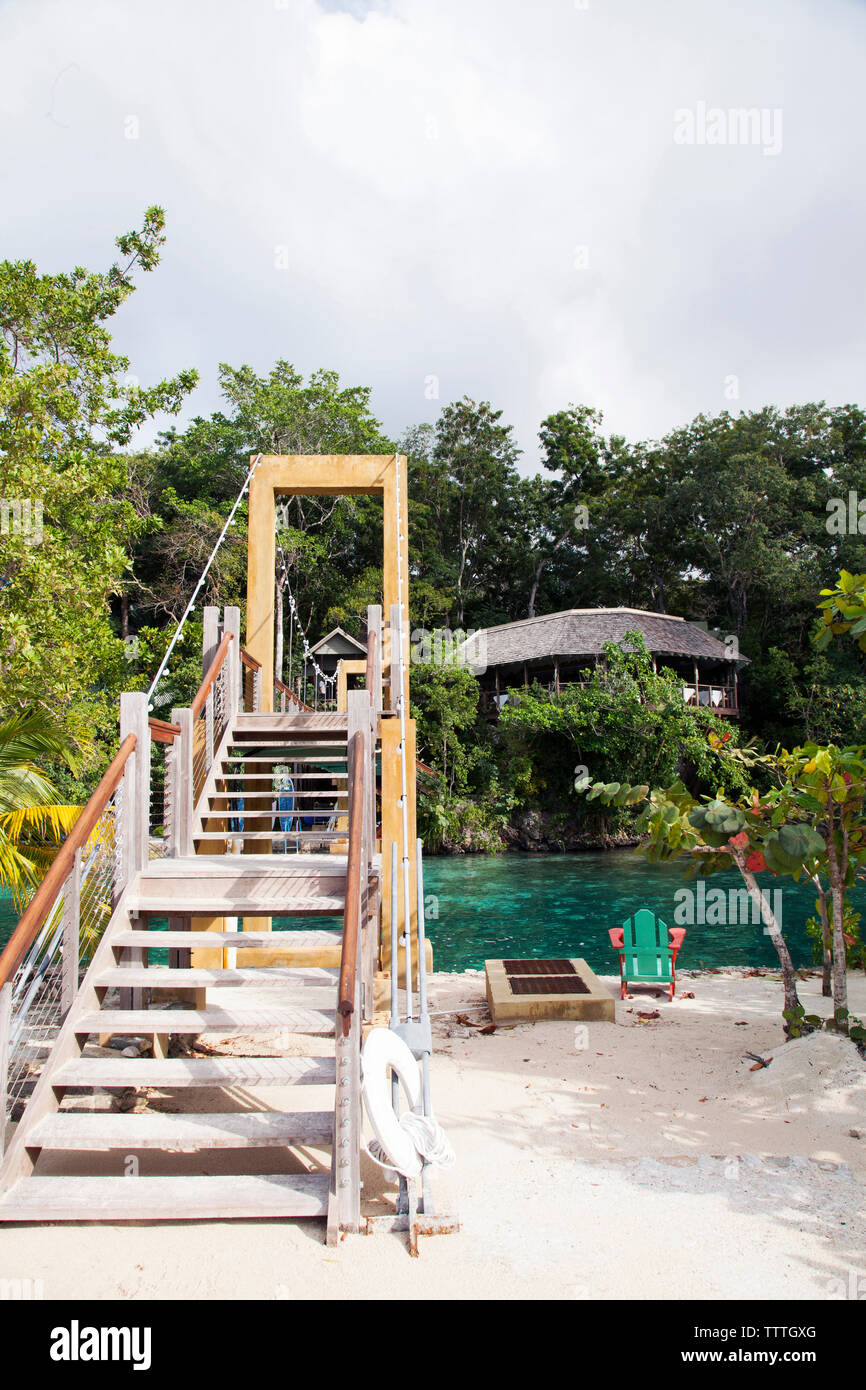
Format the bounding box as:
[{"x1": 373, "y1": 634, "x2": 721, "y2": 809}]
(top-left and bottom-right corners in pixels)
[{"x1": 0, "y1": 207, "x2": 196, "y2": 724}]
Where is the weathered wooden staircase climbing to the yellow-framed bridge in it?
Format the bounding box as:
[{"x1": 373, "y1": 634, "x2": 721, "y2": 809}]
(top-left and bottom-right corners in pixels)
[{"x1": 0, "y1": 642, "x2": 379, "y2": 1241}]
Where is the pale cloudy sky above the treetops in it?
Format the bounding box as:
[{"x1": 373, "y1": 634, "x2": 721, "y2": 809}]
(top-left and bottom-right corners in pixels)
[{"x1": 0, "y1": 0, "x2": 866, "y2": 468}]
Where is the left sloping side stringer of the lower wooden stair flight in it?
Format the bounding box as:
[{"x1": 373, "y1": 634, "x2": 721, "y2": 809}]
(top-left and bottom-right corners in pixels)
[{"x1": 0, "y1": 889, "x2": 139, "y2": 1198}]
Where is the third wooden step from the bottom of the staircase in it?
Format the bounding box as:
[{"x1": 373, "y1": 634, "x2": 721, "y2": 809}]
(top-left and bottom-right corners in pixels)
[{"x1": 51, "y1": 1056, "x2": 336, "y2": 1090}]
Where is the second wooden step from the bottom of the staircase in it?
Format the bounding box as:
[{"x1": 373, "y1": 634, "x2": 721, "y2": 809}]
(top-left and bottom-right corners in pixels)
[{"x1": 28, "y1": 1111, "x2": 334, "y2": 1154}]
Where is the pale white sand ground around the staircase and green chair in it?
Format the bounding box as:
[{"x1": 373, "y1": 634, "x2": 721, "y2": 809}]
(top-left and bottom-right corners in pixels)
[{"x1": 0, "y1": 972, "x2": 866, "y2": 1300}]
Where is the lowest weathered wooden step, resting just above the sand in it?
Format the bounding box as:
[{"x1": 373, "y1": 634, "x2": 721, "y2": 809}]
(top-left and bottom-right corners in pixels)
[{"x1": 0, "y1": 1173, "x2": 329, "y2": 1222}]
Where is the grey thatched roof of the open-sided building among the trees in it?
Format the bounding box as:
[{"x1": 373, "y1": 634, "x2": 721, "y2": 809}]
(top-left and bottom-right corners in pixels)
[{"x1": 466, "y1": 607, "x2": 745, "y2": 666}]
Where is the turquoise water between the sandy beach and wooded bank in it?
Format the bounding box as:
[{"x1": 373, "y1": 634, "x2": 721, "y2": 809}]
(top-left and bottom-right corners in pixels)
[{"x1": 0, "y1": 851, "x2": 866, "y2": 974}]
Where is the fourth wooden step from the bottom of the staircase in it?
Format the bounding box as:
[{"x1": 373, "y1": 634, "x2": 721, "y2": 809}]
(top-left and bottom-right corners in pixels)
[{"x1": 75, "y1": 1008, "x2": 336, "y2": 1037}]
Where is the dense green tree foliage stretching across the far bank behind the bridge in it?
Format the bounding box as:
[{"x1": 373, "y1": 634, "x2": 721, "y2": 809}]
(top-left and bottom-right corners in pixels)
[{"x1": 0, "y1": 209, "x2": 866, "y2": 867}]
